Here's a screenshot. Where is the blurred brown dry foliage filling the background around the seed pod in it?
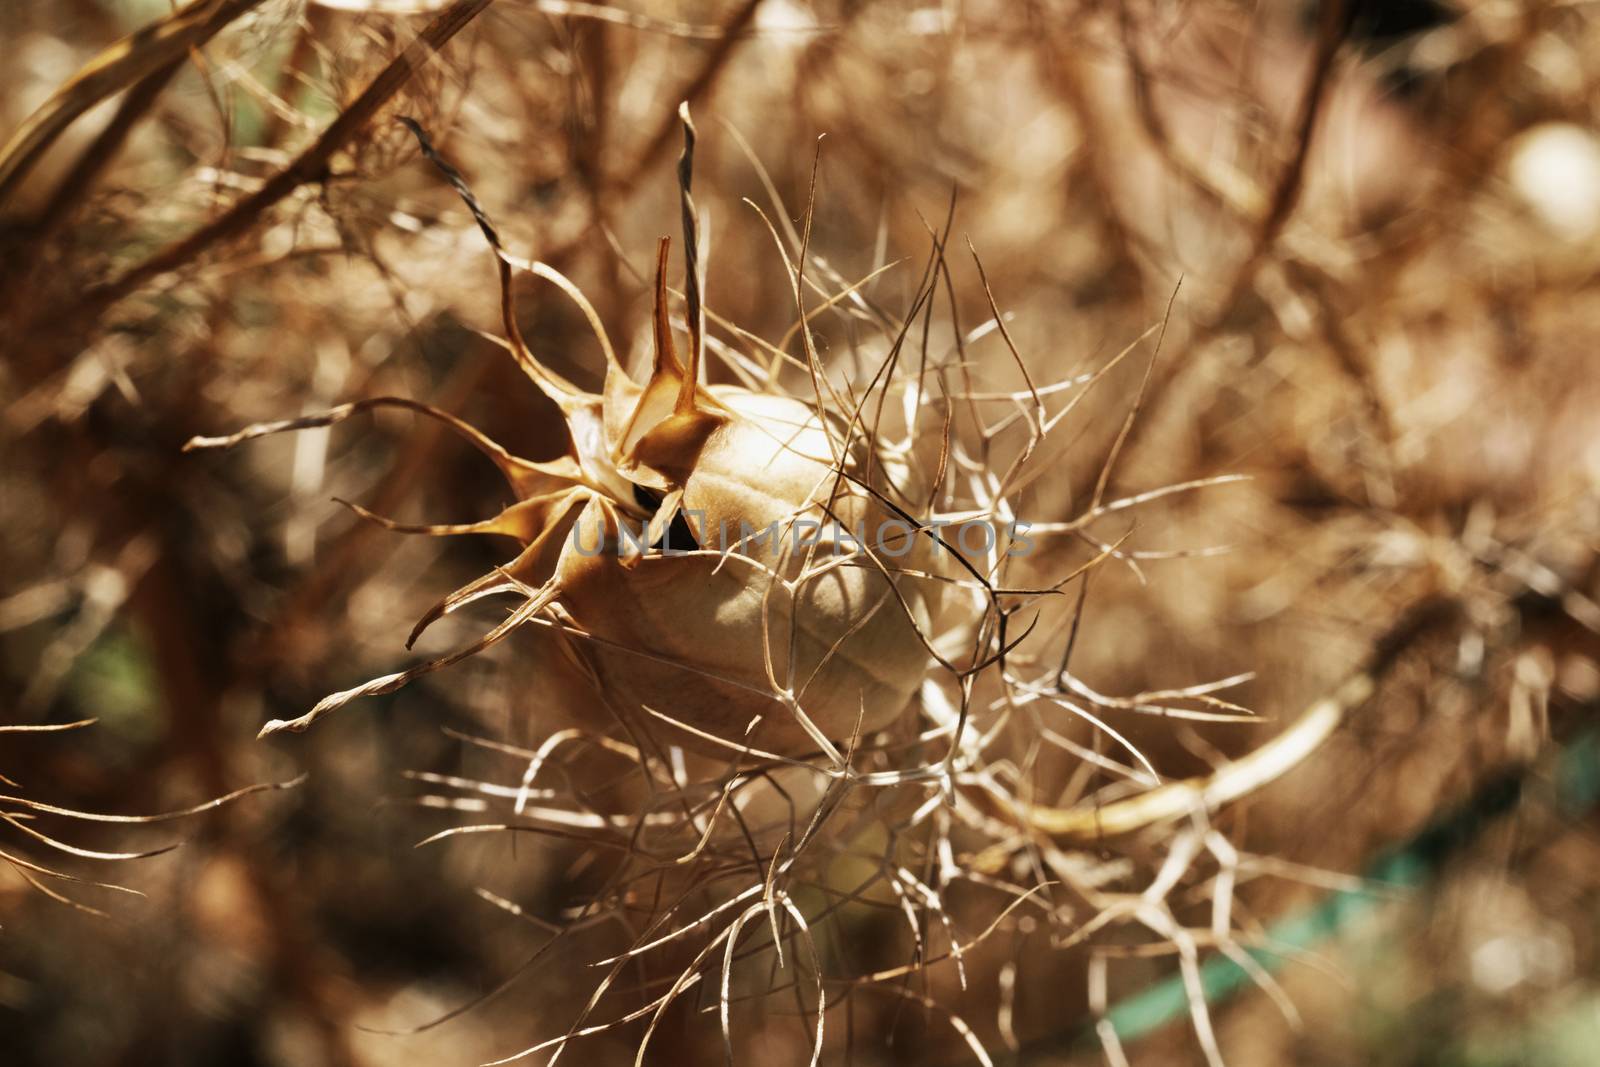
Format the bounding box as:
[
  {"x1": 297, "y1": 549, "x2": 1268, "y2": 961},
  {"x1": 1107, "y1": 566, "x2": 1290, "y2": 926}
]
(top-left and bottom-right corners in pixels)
[{"x1": 0, "y1": 0, "x2": 1600, "y2": 1067}]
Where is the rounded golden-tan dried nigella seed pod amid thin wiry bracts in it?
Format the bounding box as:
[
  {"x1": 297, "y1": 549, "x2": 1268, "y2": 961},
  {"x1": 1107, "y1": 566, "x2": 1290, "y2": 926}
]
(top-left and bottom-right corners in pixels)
[{"x1": 521, "y1": 242, "x2": 941, "y2": 755}]
